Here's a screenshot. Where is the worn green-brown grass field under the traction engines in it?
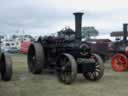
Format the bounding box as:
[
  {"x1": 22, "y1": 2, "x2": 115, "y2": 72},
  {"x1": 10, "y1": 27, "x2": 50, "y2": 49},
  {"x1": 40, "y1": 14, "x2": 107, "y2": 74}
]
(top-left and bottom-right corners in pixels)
[{"x1": 0, "y1": 54, "x2": 128, "y2": 96}]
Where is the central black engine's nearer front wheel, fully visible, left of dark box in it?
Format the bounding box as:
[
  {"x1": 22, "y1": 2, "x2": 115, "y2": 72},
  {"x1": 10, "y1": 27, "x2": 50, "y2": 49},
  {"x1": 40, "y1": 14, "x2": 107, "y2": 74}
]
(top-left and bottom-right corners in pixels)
[{"x1": 57, "y1": 53, "x2": 77, "y2": 84}]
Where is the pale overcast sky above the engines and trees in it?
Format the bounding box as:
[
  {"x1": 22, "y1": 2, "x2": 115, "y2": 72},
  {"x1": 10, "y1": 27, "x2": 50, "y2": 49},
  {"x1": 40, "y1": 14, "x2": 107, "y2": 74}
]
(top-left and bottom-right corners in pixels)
[{"x1": 0, "y1": 0, "x2": 128, "y2": 39}]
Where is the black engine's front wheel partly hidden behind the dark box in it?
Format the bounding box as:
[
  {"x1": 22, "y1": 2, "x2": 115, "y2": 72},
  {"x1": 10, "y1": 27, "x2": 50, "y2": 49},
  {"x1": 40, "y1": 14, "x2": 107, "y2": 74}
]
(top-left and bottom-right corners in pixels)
[{"x1": 83, "y1": 54, "x2": 104, "y2": 81}]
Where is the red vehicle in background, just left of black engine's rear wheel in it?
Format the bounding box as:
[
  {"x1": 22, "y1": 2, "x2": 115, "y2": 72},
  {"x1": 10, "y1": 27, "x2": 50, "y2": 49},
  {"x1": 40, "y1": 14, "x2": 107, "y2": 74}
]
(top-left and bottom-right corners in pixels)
[{"x1": 20, "y1": 41, "x2": 32, "y2": 54}]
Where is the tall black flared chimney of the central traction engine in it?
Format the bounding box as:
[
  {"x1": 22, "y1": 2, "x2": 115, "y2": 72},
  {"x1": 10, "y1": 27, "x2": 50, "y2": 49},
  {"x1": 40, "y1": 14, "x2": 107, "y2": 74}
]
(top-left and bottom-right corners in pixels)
[{"x1": 74, "y1": 12, "x2": 83, "y2": 41}]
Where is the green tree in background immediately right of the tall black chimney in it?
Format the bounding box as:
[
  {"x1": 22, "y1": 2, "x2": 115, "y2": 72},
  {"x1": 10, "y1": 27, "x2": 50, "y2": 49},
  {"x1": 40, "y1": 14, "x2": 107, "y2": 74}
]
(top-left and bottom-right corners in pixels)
[{"x1": 82, "y1": 26, "x2": 99, "y2": 39}]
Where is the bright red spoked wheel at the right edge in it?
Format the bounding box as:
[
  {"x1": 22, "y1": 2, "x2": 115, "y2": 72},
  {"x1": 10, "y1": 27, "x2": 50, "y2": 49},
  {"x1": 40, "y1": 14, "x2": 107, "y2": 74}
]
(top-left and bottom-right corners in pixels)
[{"x1": 111, "y1": 53, "x2": 128, "y2": 72}]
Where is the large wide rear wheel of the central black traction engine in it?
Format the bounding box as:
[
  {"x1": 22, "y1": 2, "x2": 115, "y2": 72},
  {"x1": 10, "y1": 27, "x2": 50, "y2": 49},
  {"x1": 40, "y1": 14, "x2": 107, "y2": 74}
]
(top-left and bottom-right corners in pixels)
[{"x1": 27, "y1": 43, "x2": 45, "y2": 74}]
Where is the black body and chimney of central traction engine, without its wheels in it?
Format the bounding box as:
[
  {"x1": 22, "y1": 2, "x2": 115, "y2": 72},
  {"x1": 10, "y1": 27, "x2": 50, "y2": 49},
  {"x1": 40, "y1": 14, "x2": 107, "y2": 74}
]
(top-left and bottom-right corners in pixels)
[{"x1": 37, "y1": 13, "x2": 95, "y2": 72}]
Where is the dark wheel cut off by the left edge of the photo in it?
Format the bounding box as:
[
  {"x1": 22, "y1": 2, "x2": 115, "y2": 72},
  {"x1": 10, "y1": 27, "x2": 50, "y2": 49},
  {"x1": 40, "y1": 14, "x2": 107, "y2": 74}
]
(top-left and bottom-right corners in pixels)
[{"x1": 0, "y1": 53, "x2": 12, "y2": 81}]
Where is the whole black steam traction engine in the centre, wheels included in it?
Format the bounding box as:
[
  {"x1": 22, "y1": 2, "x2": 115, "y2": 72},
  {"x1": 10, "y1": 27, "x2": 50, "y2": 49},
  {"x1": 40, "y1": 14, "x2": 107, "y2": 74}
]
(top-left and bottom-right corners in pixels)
[{"x1": 28, "y1": 13, "x2": 104, "y2": 84}]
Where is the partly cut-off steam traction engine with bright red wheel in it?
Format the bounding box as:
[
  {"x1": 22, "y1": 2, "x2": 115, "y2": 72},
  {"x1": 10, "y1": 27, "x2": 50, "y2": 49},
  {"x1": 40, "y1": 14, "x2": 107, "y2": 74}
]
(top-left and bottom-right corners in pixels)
[{"x1": 111, "y1": 24, "x2": 128, "y2": 72}]
